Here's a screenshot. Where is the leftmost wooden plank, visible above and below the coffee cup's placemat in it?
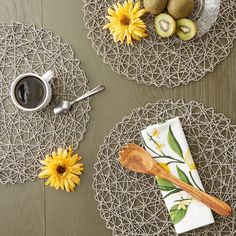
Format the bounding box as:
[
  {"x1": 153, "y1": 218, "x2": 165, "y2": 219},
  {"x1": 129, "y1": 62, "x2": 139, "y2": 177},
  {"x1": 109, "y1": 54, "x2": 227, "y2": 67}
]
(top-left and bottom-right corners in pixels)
[{"x1": 0, "y1": 0, "x2": 45, "y2": 236}]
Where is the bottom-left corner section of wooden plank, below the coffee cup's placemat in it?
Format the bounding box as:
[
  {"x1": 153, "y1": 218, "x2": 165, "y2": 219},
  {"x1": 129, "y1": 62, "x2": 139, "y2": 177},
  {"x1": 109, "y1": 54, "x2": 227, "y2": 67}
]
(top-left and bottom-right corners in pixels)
[{"x1": 0, "y1": 180, "x2": 45, "y2": 236}]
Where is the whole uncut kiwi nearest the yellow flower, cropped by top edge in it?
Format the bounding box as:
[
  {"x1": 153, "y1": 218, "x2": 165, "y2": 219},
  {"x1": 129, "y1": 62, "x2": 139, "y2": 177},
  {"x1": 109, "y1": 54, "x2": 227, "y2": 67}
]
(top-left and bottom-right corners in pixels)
[{"x1": 143, "y1": 0, "x2": 168, "y2": 15}]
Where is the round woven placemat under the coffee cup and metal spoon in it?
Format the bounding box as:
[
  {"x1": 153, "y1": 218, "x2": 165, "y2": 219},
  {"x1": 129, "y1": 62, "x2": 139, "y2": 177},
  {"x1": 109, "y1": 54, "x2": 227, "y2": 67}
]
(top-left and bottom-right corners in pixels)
[{"x1": 0, "y1": 23, "x2": 90, "y2": 184}]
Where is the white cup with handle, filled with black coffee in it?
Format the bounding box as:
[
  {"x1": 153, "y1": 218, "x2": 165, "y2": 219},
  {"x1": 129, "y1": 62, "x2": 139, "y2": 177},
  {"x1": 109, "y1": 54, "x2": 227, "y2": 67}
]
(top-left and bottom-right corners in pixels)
[{"x1": 11, "y1": 70, "x2": 53, "y2": 111}]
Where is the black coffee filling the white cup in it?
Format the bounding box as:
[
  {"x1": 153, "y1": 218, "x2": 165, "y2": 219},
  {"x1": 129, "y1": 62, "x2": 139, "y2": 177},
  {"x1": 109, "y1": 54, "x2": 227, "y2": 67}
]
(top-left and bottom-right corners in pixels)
[{"x1": 15, "y1": 76, "x2": 47, "y2": 109}]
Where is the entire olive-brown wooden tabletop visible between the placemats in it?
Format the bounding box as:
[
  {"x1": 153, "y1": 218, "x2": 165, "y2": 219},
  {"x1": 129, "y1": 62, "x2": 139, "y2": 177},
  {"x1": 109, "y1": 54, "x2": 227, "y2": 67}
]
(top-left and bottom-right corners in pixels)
[{"x1": 0, "y1": 0, "x2": 236, "y2": 236}]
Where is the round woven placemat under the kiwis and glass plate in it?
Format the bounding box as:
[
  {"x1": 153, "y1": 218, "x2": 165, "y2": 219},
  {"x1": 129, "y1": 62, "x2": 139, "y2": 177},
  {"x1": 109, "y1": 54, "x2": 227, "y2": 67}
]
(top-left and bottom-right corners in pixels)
[{"x1": 83, "y1": 0, "x2": 236, "y2": 87}]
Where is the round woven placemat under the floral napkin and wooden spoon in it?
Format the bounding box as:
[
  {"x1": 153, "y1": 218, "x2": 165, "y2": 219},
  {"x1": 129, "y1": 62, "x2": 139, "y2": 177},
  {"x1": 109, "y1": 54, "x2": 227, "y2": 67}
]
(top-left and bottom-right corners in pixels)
[{"x1": 93, "y1": 100, "x2": 236, "y2": 236}]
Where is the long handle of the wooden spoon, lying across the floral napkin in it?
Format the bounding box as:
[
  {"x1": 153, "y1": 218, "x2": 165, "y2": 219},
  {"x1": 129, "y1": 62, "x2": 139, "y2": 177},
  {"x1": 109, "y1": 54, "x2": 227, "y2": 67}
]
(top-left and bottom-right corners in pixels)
[{"x1": 152, "y1": 164, "x2": 232, "y2": 216}]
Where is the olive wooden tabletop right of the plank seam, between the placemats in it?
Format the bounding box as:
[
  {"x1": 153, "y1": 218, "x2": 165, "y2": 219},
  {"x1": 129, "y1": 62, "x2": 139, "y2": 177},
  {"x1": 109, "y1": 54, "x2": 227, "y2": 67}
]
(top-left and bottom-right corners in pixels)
[{"x1": 43, "y1": 0, "x2": 236, "y2": 236}]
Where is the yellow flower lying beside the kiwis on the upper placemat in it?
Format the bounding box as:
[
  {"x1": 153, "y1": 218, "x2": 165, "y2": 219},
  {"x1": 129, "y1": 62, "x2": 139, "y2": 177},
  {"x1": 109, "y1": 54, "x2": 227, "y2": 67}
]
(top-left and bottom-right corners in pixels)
[{"x1": 103, "y1": 0, "x2": 148, "y2": 45}]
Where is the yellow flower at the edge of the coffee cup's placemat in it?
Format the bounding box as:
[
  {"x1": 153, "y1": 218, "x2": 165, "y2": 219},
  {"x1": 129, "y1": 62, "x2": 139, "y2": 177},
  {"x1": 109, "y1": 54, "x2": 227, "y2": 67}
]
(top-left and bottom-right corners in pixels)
[{"x1": 38, "y1": 147, "x2": 84, "y2": 192}]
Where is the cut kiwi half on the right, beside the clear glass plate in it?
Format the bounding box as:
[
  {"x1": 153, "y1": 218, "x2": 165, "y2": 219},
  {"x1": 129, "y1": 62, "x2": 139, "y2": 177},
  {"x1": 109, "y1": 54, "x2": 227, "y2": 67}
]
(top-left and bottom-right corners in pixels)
[{"x1": 176, "y1": 19, "x2": 197, "y2": 41}]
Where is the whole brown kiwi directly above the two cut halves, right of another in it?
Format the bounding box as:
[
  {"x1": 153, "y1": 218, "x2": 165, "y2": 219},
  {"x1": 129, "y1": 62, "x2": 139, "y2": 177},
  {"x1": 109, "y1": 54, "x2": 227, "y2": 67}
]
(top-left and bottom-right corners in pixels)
[{"x1": 167, "y1": 0, "x2": 193, "y2": 20}]
